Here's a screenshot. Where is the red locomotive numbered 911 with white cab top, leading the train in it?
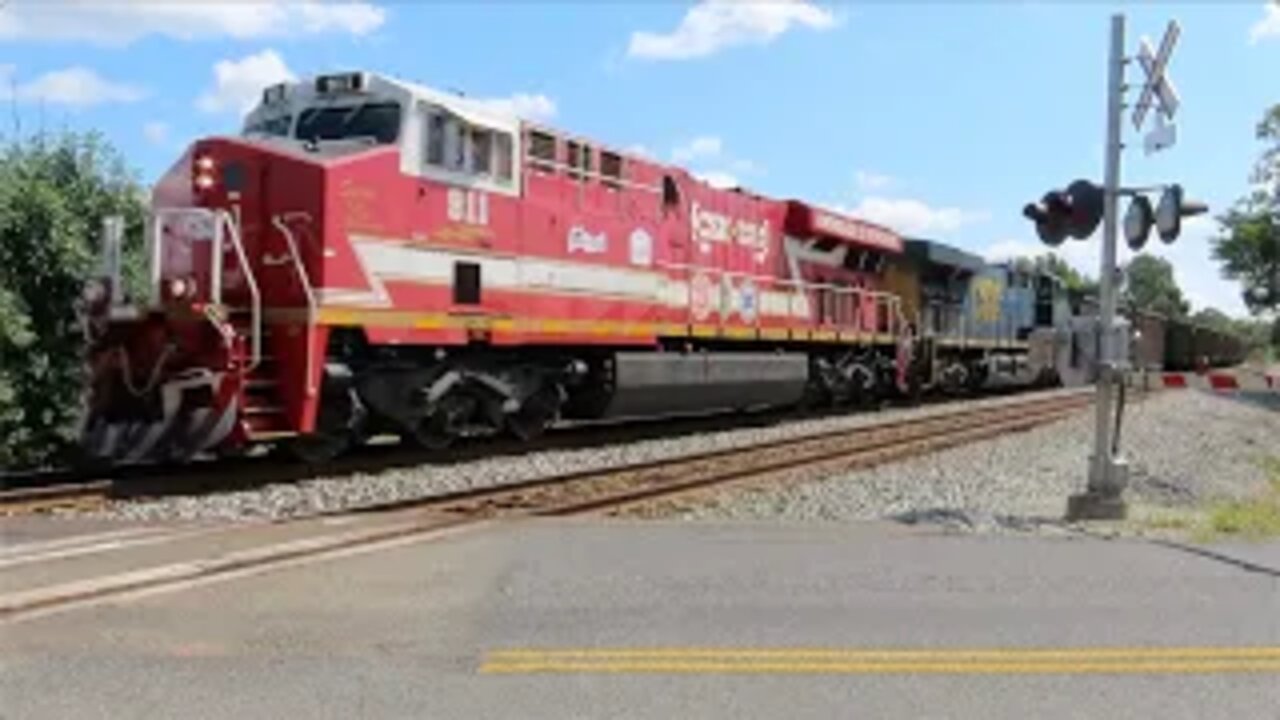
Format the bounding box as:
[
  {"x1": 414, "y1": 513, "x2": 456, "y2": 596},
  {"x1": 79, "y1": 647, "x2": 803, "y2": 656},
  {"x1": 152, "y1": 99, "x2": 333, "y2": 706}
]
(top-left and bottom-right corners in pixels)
[{"x1": 83, "y1": 73, "x2": 913, "y2": 461}]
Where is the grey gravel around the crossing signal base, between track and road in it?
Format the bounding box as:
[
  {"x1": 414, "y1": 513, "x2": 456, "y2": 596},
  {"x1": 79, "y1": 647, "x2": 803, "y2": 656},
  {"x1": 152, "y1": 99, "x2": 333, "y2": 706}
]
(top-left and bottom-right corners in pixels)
[{"x1": 646, "y1": 391, "x2": 1280, "y2": 532}]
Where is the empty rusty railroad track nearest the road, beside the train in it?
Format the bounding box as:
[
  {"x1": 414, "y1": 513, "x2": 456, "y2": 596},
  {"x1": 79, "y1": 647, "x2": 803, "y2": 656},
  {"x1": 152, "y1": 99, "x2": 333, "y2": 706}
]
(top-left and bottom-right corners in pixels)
[{"x1": 0, "y1": 391, "x2": 1092, "y2": 620}]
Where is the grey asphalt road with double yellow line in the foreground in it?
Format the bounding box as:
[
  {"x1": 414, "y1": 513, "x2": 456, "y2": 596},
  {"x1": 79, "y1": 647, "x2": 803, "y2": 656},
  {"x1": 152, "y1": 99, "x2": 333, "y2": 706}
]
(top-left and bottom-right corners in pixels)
[{"x1": 0, "y1": 521, "x2": 1280, "y2": 720}]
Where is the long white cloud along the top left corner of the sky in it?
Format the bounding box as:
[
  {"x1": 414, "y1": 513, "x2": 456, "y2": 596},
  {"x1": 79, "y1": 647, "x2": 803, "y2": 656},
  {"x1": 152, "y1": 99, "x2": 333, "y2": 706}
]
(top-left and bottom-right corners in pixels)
[{"x1": 0, "y1": 0, "x2": 387, "y2": 45}]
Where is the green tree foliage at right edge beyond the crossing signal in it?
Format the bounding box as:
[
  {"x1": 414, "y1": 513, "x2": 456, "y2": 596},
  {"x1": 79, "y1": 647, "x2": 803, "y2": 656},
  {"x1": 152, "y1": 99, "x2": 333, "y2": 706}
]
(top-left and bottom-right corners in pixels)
[{"x1": 1212, "y1": 105, "x2": 1280, "y2": 316}]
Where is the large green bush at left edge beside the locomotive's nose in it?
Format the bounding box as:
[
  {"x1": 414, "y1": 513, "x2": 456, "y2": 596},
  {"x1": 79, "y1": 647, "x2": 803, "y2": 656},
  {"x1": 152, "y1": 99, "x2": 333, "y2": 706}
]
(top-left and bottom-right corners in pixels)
[{"x1": 0, "y1": 133, "x2": 145, "y2": 468}]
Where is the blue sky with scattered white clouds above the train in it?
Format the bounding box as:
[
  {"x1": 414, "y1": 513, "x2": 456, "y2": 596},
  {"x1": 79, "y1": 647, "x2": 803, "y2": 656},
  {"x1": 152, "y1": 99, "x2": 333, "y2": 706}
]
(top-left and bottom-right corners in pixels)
[{"x1": 0, "y1": 0, "x2": 1280, "y2": 315}]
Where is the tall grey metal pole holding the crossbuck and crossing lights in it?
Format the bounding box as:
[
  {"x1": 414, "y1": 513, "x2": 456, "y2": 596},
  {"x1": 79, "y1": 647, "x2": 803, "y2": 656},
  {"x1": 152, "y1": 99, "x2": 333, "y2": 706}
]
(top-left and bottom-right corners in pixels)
[{"x1": 1068, "y1": 14, "x2": 1128, "y2": 519}]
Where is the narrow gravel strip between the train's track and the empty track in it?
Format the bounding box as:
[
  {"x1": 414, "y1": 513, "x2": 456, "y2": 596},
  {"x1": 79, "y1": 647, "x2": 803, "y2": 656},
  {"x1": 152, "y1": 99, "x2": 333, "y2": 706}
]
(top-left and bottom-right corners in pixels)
[{"x1": 85, "y1": 391, "x2": 1085, "y2": 520}]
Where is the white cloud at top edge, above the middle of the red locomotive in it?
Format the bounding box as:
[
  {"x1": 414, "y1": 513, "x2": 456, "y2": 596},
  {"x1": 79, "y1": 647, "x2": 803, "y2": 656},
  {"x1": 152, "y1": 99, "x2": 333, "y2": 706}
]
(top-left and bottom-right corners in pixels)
[{"x1": 627, "y1": 0, "x2": 836, "y2": 60}]
